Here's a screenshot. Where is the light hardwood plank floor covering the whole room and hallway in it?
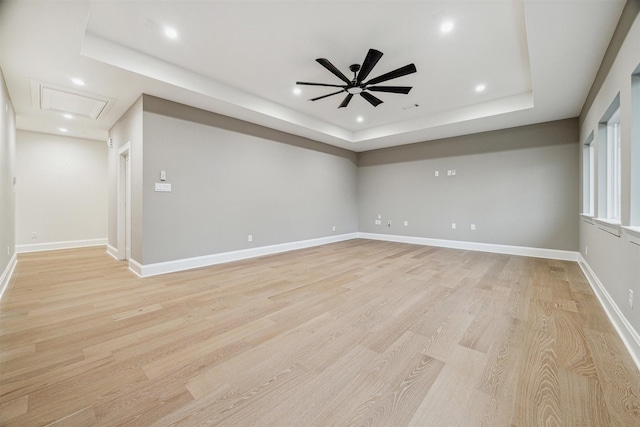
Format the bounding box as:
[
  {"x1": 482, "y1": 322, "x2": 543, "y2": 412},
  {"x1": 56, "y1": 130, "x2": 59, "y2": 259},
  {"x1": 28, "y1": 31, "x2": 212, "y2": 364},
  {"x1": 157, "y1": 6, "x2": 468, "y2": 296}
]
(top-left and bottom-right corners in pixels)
[{"x1": 0, "y1": 240, "x2": 640, "y2": 427}]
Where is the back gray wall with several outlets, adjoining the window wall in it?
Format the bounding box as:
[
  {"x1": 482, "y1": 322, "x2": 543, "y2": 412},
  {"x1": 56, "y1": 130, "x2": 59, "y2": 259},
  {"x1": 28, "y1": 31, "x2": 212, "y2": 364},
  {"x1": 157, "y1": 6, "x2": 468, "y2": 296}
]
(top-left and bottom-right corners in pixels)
[{"x1": 358, "y1": 119, "x2": 579, "y2": 251}]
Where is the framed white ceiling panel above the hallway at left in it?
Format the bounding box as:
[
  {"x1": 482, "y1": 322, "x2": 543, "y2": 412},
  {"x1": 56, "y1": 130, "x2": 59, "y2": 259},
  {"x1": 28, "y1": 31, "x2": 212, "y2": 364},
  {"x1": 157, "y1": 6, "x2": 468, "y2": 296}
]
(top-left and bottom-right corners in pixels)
[{"x1": 31, "y1": 80, "x2": 116, "y2": 120}]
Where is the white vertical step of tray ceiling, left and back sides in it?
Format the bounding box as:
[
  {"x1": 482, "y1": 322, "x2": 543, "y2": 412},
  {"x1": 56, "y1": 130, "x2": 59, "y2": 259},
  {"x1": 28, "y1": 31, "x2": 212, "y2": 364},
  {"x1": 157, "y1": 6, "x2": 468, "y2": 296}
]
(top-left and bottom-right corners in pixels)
[{"x1": 81, "y1": 31, "x2": 534, "y2": 148}]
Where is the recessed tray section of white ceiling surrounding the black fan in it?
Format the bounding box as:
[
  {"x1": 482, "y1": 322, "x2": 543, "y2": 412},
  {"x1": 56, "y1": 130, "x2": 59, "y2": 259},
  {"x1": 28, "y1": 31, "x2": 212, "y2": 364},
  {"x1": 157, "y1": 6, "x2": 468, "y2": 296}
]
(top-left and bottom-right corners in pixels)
[{"x1": 77, "y1": 0, "x2": 534, "y2": 148}]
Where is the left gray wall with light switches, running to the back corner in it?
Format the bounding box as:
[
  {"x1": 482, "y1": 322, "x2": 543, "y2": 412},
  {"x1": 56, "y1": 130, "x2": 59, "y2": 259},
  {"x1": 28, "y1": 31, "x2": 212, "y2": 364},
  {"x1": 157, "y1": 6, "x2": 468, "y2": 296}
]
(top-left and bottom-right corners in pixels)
[{"x1": 136, "y1": 95, "x2": 358, "y2": 264}]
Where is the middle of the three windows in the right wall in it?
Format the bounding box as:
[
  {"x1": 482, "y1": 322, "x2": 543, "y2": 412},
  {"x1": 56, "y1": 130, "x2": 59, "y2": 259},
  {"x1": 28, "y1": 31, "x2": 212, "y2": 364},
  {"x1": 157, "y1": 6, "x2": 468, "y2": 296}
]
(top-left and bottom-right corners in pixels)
[{"x1": 607, "y1": 108, "x2": 622, "y2": 222}]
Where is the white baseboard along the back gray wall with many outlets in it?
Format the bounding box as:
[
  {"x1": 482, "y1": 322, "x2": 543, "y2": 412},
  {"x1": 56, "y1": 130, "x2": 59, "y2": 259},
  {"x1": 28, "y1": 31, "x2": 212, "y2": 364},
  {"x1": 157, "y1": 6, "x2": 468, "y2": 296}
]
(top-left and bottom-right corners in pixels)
[{"x1": 357, "y1": 233, "x2": 579, "y2": 261}]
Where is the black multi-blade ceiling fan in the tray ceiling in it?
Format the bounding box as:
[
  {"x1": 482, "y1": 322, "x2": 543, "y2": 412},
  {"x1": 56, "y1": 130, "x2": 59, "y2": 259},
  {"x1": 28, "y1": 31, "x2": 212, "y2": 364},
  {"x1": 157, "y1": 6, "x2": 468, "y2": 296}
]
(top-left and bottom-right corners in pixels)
[{"x1": 296, "y1": 49, "x2": 416, "y2": 108}]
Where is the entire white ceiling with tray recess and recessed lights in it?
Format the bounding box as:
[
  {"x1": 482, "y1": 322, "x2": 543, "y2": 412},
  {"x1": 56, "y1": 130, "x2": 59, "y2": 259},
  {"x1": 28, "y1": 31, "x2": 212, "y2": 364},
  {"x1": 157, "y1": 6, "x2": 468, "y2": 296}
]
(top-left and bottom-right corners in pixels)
[{"x1": 0, "y1": 0, "x2": 625, "y2": 151}]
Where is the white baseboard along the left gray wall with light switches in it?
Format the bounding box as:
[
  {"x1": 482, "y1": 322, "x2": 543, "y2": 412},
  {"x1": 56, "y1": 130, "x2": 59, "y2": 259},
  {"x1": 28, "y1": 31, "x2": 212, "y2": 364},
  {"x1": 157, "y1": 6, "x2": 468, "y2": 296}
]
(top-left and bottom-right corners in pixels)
[{"x1": 134, "y1": 233, "x2": 358, "y2": 277}]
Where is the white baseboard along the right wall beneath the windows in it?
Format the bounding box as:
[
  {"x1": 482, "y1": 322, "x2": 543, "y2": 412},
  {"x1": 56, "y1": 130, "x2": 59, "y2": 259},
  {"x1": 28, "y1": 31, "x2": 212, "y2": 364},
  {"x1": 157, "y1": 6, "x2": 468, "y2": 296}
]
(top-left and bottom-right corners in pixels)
[{"x1": 578, "y1": 254, "x2": 640, "y2": 370}]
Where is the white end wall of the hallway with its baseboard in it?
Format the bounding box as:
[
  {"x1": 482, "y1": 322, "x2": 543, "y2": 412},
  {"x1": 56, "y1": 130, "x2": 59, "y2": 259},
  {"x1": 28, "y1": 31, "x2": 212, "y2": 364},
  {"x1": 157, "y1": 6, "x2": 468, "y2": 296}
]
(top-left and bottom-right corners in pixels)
[{"x1": 16, "y1": 131, "x2": 107, "y2": 251}]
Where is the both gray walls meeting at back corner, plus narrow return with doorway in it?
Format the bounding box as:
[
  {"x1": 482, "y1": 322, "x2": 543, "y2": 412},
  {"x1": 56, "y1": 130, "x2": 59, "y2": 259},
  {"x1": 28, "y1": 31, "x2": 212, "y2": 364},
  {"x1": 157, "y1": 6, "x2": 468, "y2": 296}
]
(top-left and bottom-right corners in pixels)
[{"x1": 109, "y1": 95, "x2": 579, "y2": 265}]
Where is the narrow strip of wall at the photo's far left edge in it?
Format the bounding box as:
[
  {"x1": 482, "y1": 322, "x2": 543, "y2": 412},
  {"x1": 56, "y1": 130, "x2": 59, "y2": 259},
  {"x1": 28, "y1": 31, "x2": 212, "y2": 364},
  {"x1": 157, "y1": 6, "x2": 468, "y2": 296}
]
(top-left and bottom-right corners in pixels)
[{"x1": 0, "y1": 70, "x2": 16, "y2": 276}]
